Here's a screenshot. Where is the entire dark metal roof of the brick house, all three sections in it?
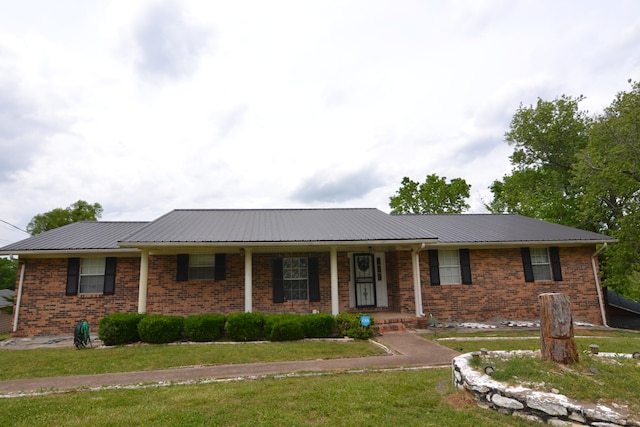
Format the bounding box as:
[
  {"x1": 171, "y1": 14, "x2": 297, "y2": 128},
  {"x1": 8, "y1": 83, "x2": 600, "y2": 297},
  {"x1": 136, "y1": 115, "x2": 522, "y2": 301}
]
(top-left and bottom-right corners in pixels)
[{"x1": 0, "y1": 209, "x2": 616, "y2": 255}]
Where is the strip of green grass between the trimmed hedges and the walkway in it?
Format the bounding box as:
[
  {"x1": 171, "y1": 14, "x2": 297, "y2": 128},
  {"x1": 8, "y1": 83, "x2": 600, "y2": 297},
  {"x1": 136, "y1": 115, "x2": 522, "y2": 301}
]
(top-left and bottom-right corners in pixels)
[{"x1": 0, "y1": 341, "x2": 384, "y2": 381}]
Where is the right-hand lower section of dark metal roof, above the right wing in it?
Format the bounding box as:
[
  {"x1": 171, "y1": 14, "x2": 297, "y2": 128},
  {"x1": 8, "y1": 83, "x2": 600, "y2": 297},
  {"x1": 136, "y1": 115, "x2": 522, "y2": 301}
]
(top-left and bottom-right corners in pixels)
[{"x1": 393, "y1": 214, "x2": 615, "y2": 244}]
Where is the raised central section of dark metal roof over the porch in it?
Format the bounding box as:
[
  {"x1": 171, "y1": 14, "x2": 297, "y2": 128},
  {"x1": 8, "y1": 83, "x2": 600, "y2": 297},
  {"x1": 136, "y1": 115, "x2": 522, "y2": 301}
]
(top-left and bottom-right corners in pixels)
[{"x1": 122, "y1": 209, "x2": 436, "y2": 246}]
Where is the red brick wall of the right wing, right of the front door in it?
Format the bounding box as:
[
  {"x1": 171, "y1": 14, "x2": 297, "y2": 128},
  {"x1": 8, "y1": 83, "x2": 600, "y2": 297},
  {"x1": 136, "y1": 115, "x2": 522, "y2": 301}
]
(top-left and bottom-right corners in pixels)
[{"x1": 420, "y1": 247, "x2": 602, "y2": 324}]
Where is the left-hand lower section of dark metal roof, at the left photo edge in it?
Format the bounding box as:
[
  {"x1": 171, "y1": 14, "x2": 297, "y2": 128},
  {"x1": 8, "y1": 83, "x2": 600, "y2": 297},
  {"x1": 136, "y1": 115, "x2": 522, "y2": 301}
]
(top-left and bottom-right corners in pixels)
[{"x1": 0, "y1": 221, "x2": 147, "y2": 255}]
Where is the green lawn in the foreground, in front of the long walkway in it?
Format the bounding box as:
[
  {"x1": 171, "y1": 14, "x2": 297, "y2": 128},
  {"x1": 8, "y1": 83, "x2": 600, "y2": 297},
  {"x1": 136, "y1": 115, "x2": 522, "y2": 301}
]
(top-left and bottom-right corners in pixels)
[{"x1": 0, "y1": 368, "x2": 539, "y2": 427}]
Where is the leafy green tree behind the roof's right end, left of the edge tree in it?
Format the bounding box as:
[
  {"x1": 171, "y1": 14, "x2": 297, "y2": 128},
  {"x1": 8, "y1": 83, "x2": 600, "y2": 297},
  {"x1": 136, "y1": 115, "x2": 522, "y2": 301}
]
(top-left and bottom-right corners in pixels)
[{"x1": 486, "y1": 95, "x2": 590, "y2": 227}]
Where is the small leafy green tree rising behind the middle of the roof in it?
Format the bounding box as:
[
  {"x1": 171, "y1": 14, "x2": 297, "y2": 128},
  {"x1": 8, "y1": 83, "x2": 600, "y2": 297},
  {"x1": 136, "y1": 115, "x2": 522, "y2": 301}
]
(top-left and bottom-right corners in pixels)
[{"x1": 389, "y1": 174, "x2": 471, "y2": 215}]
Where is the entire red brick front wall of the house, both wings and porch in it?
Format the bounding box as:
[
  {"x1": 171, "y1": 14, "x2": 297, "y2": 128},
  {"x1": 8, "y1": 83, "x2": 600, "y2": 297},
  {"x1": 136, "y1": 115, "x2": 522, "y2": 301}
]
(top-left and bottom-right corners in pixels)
[{"x1": 15, "y1": 244, "x2": 601, "y2": 336}]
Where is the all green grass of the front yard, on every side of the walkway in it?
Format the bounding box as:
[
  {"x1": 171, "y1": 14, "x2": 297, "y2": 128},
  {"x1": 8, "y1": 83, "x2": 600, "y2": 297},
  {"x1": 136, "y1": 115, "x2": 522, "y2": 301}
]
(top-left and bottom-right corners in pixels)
[{"x1": 0, "y1": 330, "x2": 640, "y2": 426}]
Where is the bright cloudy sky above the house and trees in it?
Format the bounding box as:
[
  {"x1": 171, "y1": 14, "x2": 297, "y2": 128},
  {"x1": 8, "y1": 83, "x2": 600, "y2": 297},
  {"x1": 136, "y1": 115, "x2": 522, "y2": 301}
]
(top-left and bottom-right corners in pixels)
[{"x1": 0, "y1": 0, "x2": 640, "y2": 246}]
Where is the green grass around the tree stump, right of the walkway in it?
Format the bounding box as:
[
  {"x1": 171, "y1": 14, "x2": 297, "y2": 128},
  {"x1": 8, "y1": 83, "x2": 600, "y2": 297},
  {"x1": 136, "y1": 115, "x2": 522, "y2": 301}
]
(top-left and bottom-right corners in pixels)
[{"x1": 425, "y1": 330, "x2": 640, "y2": 412}]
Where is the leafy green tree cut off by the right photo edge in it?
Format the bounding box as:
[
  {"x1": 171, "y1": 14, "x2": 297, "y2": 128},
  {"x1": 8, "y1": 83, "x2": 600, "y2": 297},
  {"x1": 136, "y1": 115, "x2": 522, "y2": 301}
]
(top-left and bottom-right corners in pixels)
[{"x1": 572, "y1": 81, "x2": 640, "y2": 301}]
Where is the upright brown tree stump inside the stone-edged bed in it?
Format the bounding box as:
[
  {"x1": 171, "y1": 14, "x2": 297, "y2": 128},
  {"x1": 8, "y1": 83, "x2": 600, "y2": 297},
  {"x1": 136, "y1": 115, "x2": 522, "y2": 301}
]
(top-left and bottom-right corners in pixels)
[{"x1": 538, "y1": 293, "x2": 580, "y2": 365}]
